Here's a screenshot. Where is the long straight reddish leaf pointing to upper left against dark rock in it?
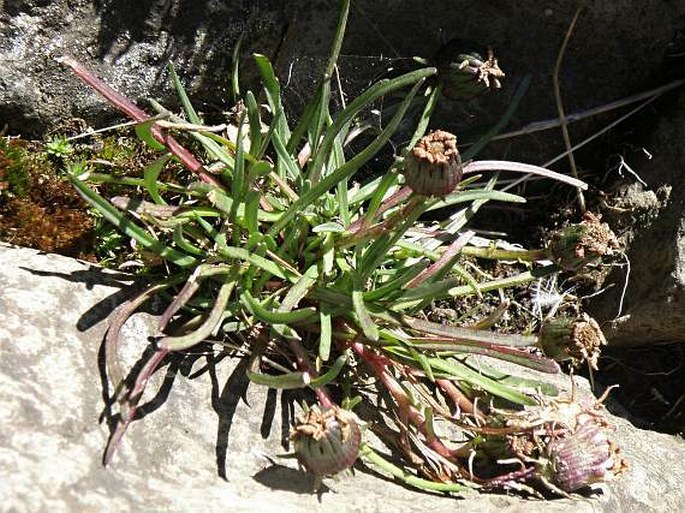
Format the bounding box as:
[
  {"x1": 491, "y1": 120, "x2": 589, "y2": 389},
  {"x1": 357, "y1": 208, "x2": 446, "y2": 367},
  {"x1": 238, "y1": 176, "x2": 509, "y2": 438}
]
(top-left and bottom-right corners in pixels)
[{"x1": 57, "y1": 56, "x2": 223, "y2": 188}]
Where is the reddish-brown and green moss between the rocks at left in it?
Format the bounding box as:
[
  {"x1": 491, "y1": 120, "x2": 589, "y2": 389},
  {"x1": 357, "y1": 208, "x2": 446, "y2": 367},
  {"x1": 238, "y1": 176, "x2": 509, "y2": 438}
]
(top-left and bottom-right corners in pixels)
[{"x1": 0, "y1": 135, "x2": 156, "y2": 265}]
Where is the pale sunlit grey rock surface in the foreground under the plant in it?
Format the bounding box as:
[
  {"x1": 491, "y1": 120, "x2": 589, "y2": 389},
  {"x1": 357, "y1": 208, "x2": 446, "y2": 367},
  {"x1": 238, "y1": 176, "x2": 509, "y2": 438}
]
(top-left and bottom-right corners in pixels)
[{"x1": 0, "y1": 241, "x2": 685, "y2": 513}]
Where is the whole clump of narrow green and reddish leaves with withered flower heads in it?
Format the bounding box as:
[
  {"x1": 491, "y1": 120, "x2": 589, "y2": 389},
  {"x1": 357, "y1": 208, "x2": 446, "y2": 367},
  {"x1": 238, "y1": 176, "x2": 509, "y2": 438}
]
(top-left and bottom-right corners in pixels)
[{"x1": 61, "y1": 1, "x2": 626, "y2": 494}]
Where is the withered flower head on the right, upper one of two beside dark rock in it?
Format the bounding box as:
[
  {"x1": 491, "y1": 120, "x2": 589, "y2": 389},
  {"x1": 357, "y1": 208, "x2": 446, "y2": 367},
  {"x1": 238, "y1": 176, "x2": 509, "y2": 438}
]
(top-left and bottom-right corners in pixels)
[{"x1": 550, "y1": 212, "x2": 620, "y2": 271}]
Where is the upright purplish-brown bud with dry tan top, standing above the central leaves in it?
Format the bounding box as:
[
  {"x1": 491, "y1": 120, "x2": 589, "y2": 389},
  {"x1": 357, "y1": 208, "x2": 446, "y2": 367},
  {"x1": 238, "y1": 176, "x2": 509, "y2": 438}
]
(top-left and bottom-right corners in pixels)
[{"x1": 404, "y1": 130, "x2": 463, "y2": 197}]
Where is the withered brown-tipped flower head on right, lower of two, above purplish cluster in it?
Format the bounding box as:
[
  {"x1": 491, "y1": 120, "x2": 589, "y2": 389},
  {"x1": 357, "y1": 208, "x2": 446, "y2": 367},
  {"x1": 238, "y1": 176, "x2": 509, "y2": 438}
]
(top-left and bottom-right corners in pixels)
[{"x1": 539, "y1": 313, "x2": 607, "y2": 370}]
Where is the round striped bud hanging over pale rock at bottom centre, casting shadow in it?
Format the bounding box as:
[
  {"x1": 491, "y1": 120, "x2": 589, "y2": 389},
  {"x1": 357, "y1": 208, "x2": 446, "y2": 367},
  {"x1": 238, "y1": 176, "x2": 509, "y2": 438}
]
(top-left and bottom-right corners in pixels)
[{"x1": 290, "y1": 406, "x2": 361, "y2": 478}]
